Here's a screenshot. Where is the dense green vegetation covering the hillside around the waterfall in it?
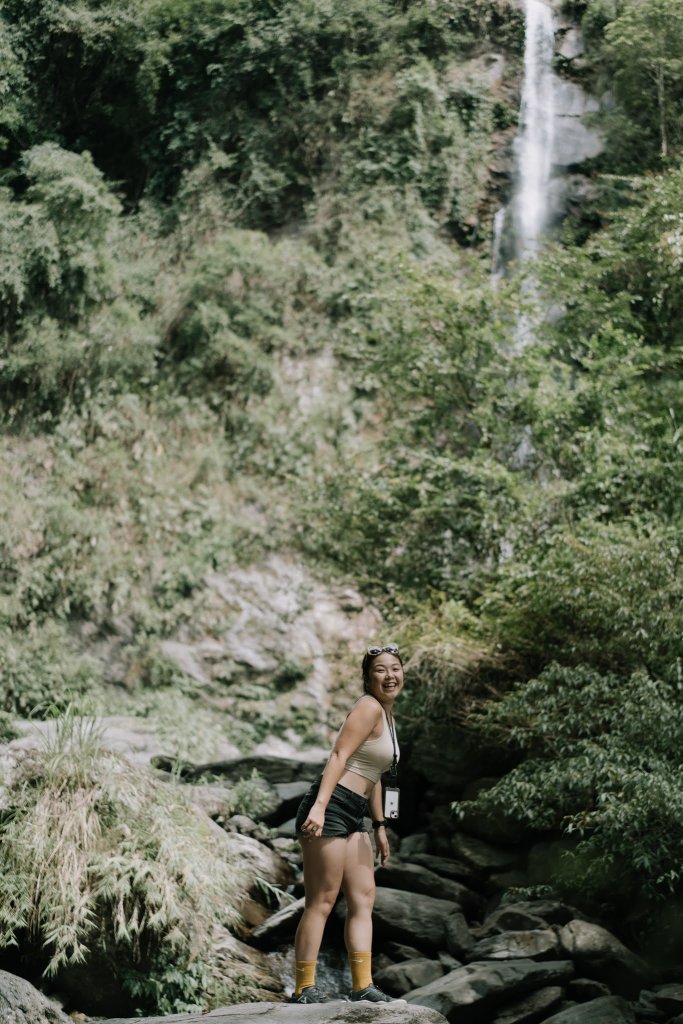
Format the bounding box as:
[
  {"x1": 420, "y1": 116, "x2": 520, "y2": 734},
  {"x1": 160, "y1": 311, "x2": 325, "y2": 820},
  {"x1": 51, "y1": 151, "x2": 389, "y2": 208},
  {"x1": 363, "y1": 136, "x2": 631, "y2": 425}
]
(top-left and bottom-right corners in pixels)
[{"x1": 0, "y1": 0, "x2": 683, "y2": 1009}]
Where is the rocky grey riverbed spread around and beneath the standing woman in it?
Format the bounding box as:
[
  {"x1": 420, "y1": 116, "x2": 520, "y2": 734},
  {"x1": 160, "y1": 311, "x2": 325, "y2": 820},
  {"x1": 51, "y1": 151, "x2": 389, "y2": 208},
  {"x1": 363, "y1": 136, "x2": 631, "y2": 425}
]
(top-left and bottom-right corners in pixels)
[{"x1": 0, "y1": 758, "x2": 683, "y2": 1024}]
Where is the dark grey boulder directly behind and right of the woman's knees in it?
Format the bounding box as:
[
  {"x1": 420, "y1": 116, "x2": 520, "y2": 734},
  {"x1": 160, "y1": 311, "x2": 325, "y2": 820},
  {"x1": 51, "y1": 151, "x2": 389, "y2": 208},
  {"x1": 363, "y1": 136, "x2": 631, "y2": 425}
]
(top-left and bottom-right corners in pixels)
[{"x1": 344, "y1": 888, "x2": 454, "y2": 953}]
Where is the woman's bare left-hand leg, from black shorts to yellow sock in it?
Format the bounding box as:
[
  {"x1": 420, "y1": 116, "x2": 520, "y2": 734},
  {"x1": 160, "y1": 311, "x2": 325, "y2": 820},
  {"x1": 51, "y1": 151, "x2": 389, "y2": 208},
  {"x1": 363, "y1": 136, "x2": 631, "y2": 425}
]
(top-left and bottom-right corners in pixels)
[{"x1": 294, "y1": 837, "x2": 349, "y2": 961}]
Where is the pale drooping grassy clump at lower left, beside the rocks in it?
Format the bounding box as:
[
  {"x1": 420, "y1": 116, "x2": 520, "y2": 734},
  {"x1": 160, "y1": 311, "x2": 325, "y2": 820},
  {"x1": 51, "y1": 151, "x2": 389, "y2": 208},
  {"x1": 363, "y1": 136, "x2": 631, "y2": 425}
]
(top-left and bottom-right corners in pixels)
[{"x1": 0, "y1": 711, "x2": 260, "y2": 1012}]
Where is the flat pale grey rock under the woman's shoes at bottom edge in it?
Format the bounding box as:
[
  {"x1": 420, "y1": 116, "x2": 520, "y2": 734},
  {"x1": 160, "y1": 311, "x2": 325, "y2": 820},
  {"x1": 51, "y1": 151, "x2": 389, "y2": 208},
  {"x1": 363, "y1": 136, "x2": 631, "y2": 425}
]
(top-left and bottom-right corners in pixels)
[{"x1": 105, "y1": 999, "x2": 443, "y2": 1024}]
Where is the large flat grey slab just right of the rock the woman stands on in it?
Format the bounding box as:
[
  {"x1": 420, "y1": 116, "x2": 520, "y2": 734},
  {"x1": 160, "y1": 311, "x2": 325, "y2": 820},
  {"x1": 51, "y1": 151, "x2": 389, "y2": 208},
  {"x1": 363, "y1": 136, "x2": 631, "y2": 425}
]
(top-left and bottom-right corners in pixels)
[{"x1": 407, "y1": 959, "x2": 573, "y2": 1024}]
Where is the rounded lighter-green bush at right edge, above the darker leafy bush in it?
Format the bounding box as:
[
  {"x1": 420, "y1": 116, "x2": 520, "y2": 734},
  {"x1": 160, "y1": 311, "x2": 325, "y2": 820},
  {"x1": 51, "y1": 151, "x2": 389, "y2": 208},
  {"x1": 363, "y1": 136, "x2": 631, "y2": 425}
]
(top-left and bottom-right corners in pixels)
[{"x1": 484, "y1": 520, "x2": 683, "y2": 682}]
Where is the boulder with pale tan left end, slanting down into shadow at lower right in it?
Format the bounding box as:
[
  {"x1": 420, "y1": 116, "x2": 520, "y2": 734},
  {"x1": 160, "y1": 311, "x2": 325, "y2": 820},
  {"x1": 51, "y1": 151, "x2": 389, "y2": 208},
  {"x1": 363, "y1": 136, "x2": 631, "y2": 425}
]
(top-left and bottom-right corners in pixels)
[{"x1": 559, "y1": 921, "x2": 648, "y2": 998}]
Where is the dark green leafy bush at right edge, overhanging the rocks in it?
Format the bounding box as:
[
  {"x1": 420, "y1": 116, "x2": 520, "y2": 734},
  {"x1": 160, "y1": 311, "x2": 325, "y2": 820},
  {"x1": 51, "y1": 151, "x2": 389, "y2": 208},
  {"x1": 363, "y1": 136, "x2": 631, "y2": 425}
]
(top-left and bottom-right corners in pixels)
[{"x1": 461, "y1": 665, "x2": 683, "y2": 908}]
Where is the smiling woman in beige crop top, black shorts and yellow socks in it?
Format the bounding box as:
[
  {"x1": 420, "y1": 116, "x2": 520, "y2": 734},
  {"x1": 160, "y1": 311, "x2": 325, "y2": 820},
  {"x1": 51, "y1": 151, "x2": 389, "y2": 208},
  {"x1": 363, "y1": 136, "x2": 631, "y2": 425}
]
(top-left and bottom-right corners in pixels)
[{"x1": 292, "y1": 644, "x2": 403, "y2": 1002}]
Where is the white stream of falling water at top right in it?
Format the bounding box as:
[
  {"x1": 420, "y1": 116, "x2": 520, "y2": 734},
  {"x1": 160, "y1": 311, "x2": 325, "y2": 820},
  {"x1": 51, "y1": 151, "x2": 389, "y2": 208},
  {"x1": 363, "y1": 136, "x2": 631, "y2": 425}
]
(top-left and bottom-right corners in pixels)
[{"x1": 513, "y1": 0, "x2": 555, "y2": 261}]
